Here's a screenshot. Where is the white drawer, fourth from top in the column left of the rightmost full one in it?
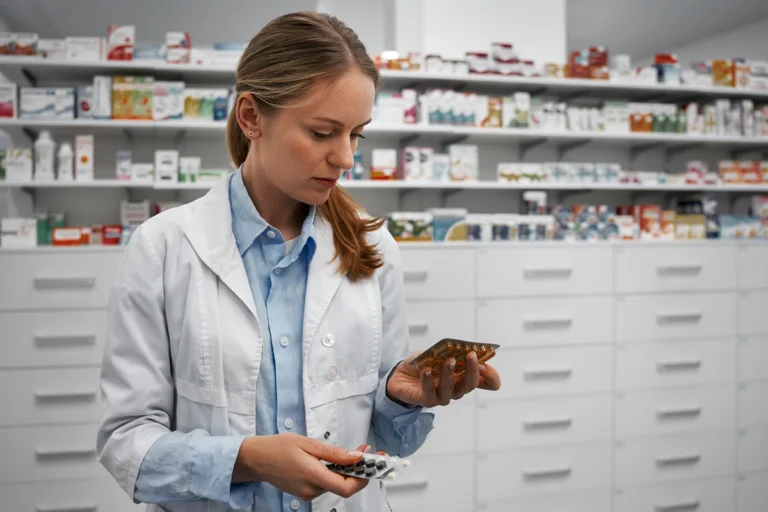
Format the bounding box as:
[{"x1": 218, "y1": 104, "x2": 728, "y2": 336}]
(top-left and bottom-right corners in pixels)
[{"x1": 477, "y1": 394, "x2": 613, "y2": 451}]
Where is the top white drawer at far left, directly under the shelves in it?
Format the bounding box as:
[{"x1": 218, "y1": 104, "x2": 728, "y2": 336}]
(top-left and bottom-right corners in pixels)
[{"x1": 0, "y1": 250, "x2": 122, "y2": 310}]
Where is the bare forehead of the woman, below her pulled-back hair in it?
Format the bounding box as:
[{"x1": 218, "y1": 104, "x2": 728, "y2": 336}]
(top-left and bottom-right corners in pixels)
[{"x1": 288, "y1": 70, "x2": 376, "y2": 128}]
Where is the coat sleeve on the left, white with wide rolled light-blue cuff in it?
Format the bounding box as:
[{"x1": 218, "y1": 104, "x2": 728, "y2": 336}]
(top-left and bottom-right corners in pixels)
[{"x1": 96, "y1": 226, "x2": 253, "y2": 508}]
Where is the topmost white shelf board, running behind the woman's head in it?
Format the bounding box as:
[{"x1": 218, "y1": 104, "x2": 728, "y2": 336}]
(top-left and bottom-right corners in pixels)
[{"x1": 0, "y1": 56, "x2": 768, "y2": 100}]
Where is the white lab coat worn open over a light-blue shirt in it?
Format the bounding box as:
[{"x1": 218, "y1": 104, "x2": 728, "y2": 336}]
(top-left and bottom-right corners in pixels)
[{"x1": 98, "y1": 179, "x2": 416, "y2": 512}]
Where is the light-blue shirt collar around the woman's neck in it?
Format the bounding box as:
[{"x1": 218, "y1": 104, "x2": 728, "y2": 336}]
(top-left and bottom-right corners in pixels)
[{"x1": 229, "y1": 166, "x2": 316, "y2": 258}]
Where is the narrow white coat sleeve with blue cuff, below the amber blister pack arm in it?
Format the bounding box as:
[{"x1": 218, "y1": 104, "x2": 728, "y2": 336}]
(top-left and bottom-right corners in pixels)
[{"x1": 371, "y1": 231, "x2": 434, "y2": 457}]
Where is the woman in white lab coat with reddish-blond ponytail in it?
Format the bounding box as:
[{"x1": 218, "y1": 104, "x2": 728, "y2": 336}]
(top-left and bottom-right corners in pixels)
[{"x1": 98, "y1": 13, "x2": 500, "y2": 512}]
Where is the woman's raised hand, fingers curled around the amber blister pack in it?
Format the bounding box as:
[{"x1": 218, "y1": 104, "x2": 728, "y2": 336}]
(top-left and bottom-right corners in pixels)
[{"x1": 387, "y1": 352, "x2": 501, "y2": 407}]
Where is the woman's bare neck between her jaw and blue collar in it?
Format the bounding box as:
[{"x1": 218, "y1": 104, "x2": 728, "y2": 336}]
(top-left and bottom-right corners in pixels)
[{"x1": 243, "y1": 161, "x2": 309, "y2": 240}]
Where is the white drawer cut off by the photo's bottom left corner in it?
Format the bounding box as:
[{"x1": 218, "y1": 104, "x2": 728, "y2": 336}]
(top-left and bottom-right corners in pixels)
[{"x1": 0, "y1": 472, "x2": 146, "y2": 512}]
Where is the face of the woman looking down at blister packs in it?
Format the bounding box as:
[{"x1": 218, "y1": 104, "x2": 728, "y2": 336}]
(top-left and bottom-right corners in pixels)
[{"x1": 241, "y1": 69, "x2": 376, "y2": 205}]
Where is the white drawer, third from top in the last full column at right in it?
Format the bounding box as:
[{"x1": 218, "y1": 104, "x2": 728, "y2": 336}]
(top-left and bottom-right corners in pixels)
[{"x1": 616, "y1": 339, "x2": 736, "y2": 390}]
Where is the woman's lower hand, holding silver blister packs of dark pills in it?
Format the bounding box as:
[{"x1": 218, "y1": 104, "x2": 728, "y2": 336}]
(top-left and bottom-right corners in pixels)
[{"x1": 232, "y1": 434, "x2": 368, "y2": 501}]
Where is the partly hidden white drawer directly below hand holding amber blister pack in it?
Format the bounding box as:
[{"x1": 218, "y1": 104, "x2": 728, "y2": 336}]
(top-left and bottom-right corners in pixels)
[{"x1": 417, "y1": 400, "x2": 476, "y2": 456}]
